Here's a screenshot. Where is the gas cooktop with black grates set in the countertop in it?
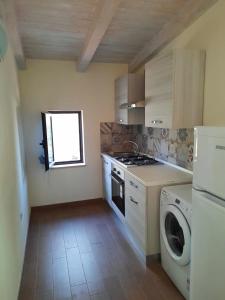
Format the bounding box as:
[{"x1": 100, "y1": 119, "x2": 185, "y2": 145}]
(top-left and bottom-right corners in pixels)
[{"x1": 110, "y1": 153, "x2": 158, "y2": 166}]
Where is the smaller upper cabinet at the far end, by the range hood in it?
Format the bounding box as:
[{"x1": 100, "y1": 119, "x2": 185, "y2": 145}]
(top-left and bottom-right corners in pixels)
[{"x1": 115, "y1": 74, "x2": 145, "y2": 125}]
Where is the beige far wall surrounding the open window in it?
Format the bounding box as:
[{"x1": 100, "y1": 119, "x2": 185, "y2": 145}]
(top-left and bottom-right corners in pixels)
[{"x1": 19, "y1": 60, "x2": 127, "y2": 206}]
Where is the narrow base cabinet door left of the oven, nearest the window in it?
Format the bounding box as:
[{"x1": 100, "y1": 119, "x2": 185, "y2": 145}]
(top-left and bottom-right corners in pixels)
[{"x1": 102, "y1": 156, "x2": 112, "y2": 206}]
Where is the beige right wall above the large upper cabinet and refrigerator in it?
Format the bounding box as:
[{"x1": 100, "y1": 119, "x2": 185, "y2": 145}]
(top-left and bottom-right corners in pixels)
[{"x1": 159, "y1": 0, "x2": 225, "y2": 126}]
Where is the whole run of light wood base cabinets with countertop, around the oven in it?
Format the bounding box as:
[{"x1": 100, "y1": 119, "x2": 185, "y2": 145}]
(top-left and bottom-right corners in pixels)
[{"x1": 102, "y1": 154, "x2": 192, "y2": 264}]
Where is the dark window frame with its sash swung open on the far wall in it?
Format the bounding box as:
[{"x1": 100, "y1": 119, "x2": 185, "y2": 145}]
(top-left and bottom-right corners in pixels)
[{"x1": 41, "y1": 110, "x2": 85, "y2": 171}]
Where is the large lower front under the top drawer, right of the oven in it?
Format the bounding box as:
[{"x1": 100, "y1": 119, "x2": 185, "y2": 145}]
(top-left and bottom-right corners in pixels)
[{"x1": 125, "y1": 190, "x2": 146, "y2": 252}]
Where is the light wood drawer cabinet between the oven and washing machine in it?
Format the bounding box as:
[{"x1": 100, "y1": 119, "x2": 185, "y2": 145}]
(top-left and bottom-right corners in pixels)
[{"x1": 125, "y1": 174, "x2": 161, "y2": 262}]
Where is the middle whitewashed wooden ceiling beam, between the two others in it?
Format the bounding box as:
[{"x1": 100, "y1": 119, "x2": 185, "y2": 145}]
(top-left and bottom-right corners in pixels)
[{"x1": 77, "y1": 0, "x2": 121, "y2": 72}]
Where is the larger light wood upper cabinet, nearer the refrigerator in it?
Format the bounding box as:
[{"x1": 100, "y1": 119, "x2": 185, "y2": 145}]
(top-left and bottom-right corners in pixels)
[{"x1": 145, "y1": 49, "x2": 205, "y2": 129}]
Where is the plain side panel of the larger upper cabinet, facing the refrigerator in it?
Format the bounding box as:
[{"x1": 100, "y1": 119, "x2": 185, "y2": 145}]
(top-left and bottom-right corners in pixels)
[{"x1": 173, "y1": 49, "x2": 206, "y2": 128}]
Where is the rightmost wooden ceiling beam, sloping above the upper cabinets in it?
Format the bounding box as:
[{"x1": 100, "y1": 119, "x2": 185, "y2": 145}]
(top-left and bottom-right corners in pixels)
[{"x1": 129, "y1": 0, "x2": 218, "y2": 72}]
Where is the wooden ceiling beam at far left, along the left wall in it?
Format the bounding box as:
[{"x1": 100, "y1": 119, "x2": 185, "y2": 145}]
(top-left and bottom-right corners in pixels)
[{"x1": 3, "y1": 0, "x2": 26, "y2": 70}]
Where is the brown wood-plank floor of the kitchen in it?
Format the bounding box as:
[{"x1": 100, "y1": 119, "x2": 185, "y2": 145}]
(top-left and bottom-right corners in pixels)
[{"x1": 19, "y1": 200, "x2": 183, "y2": 300}]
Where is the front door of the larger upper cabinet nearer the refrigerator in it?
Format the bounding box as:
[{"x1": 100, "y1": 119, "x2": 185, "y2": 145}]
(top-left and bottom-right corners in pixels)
[{"x1": 145, "y1": 52, "x2": 174, "y2": 128}]
